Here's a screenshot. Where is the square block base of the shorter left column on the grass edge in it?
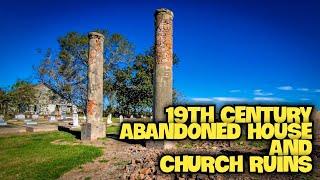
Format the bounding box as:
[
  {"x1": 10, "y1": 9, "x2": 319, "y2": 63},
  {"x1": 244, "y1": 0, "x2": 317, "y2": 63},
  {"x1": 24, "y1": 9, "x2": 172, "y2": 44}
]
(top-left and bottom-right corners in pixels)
[{"x1": 81, "y1": 122, "x2": 106, "y2": 141}]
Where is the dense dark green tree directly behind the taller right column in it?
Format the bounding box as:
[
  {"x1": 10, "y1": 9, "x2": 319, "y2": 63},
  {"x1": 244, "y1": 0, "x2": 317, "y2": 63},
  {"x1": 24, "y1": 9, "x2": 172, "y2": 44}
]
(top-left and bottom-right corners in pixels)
[{"x1": 113, "y1": 47, "x2": 179, "y2": 114}]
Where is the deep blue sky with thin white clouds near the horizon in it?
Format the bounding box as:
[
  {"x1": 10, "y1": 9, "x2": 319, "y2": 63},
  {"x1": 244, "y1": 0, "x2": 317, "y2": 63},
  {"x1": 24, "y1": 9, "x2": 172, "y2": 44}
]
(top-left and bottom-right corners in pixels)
[{"x1": 0, "y1": 0, "x2": 320, "y2": 106}]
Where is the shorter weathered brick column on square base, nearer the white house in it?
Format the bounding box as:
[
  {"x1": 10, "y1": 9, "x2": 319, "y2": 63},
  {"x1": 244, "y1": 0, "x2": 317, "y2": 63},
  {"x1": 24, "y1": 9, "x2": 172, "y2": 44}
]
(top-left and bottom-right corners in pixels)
[{"x1": 81, "y1": 32, "x2": 106, "y2": 140}]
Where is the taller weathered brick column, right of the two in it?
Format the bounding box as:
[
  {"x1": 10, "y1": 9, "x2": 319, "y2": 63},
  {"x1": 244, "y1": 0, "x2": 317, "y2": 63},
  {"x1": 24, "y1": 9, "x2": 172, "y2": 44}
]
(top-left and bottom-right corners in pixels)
[{"x1": 149, "y1": 9, "x2": 173, "y2": 148}]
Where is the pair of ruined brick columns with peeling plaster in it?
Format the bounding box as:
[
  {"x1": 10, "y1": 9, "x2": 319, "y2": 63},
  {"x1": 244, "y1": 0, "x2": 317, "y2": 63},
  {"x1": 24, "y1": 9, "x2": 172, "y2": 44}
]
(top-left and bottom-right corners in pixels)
[{"x1": 81, "y1": 9, "x2": 173, "y2": 146}]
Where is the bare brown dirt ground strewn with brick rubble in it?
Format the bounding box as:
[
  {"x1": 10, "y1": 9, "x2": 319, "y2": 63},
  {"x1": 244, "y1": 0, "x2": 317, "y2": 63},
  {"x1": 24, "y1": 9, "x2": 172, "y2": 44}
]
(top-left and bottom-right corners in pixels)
[{"x1": 58, "y1": 139, "x2": 319, "y2": 180}]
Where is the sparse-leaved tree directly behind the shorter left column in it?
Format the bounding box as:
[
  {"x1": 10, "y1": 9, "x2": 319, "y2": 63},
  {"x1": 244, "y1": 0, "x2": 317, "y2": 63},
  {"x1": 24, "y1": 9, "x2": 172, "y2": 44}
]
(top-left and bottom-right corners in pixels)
[{"x1": 36, "y1": 30, "x2": 133, "y2": 108}]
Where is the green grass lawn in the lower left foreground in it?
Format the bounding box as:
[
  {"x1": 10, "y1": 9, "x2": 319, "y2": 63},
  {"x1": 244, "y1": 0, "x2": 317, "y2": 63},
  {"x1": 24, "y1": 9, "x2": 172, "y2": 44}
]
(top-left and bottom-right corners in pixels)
[{"x1": 0, "y1": 132, "x2": 102, "y2": 179}]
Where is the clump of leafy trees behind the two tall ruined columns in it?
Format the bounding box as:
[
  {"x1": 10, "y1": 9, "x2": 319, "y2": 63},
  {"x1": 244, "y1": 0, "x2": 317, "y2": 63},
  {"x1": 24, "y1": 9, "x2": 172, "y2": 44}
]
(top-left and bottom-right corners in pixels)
[{"x1": 35, "y1": 30, "x2": 179, "y2": 115}]
